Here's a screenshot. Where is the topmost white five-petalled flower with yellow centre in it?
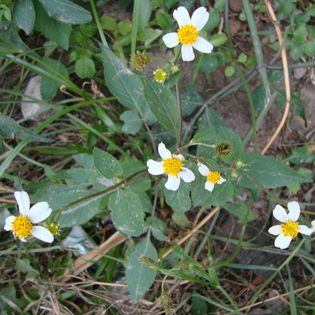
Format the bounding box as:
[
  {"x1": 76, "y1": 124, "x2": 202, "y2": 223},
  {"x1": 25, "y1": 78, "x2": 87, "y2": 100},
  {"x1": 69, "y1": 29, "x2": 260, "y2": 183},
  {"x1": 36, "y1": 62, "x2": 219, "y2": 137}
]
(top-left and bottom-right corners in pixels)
[{"x1": 163, "y1": 7, "x2": 213, "y2": 61}]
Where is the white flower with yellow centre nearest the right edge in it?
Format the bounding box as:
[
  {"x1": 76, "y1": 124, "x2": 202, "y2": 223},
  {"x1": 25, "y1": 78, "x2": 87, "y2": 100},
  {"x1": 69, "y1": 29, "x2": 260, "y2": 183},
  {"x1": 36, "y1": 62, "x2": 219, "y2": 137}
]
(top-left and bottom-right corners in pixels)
[{"x1": 268, "y1": 201, "x2": 313, "y2": 249}]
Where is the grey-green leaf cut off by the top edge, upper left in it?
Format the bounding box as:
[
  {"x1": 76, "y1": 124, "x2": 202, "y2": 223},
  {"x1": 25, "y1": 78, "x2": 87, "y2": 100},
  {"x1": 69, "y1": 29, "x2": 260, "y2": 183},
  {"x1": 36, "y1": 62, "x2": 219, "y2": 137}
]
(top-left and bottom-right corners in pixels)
[{"x1": 39, "y1": 0, "x2": 92, "y2": 24}]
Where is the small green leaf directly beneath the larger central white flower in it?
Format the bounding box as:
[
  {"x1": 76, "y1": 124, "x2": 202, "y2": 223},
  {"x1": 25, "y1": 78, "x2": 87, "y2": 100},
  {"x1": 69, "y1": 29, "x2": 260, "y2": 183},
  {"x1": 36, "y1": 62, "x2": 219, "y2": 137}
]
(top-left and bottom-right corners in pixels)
[{"x1": 164, "y1": 182, "x2": 191, "y2": 213}]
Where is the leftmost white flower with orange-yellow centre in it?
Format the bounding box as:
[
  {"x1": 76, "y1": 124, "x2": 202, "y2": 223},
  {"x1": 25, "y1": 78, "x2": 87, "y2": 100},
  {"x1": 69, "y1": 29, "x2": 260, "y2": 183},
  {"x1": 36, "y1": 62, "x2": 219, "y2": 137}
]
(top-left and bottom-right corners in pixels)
[{"x1": 4, "y1": 191, "x2": 54, "y2": 243}]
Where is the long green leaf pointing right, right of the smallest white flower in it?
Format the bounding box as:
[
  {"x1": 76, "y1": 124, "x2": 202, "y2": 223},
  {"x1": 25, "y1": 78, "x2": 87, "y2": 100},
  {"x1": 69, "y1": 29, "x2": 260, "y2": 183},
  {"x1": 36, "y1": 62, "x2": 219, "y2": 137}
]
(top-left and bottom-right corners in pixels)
[{"x1": 241, "y1": 153, "x2": 311, "y2": 188}]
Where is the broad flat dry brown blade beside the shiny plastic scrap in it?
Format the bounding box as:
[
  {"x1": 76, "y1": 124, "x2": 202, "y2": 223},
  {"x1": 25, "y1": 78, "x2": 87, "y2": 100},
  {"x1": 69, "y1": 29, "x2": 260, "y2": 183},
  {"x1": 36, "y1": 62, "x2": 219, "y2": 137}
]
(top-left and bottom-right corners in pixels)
[{"x1": 60, "y1": 232, "x2": 127, "y2": 282}]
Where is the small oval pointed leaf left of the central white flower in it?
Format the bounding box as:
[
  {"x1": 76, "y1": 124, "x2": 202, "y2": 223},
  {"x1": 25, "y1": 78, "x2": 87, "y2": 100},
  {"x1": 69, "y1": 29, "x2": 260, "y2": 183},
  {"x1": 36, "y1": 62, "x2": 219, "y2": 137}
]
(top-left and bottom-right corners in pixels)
[{"x1": 93, "y1": 148, "x2": 123, "y2": 178}]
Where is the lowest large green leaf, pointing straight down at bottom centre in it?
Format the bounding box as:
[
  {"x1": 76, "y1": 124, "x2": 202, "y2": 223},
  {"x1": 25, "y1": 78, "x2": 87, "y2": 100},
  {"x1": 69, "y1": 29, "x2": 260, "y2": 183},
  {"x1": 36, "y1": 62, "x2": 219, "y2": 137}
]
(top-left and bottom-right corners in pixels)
[{"x1": 126, "y1": 238, "x2": 157, "y2": 302}]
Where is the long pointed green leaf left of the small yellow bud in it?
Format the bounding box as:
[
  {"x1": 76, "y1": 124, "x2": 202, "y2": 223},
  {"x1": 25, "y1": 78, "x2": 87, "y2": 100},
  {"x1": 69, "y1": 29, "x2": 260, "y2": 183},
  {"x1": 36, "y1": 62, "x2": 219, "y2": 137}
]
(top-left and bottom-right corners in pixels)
[{"x1": 102, "y1": 46, "x2": 154, "y2": 123}]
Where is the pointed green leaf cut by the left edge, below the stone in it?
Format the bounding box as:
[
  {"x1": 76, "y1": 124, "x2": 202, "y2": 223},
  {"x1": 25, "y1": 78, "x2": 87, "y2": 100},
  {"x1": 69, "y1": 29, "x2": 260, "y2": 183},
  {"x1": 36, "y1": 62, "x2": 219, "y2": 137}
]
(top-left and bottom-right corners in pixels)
[{"x1": 0, "y1": 114, "x2": 52, "y2": 142}]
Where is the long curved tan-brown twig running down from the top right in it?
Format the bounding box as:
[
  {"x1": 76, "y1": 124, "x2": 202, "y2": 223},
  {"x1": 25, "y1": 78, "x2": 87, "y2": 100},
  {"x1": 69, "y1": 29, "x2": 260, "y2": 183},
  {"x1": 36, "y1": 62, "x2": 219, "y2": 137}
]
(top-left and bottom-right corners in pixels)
[{"x1": 261, "y1": 0, "x2": 291, "y2": 154}]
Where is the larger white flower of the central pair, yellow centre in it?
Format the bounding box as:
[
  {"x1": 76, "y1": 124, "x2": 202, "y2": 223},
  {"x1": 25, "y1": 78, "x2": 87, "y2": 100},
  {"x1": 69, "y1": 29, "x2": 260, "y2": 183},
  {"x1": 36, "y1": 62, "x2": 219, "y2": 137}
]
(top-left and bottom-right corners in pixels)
[{"x1": 147, "y1": 142, "x2": 195, "y2": 191}]
